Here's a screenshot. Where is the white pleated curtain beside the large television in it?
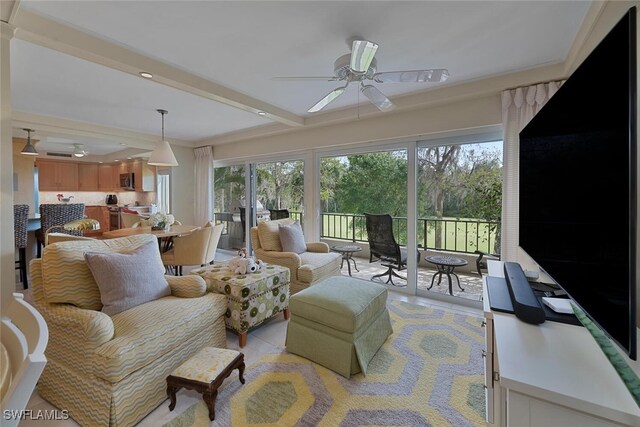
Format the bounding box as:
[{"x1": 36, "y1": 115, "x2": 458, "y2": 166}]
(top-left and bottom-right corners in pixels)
[{"x1": 500, "y1": 80, "x2": 564, "y2": 261}]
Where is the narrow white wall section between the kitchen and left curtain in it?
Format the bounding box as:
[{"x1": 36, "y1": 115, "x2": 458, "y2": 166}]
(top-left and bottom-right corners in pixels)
[{"x1": 171, "y1": 145, "x2": 195, "y2": 225}]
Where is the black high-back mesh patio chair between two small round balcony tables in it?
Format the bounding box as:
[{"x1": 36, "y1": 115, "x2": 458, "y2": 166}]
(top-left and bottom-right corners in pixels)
[{"x1": 364, "y1": 213, "x2": 420, "y2": 286}]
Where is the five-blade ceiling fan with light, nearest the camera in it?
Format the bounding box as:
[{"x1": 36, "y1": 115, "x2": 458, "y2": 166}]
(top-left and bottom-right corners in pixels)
[{"x1": 272, "y1": 40, "x2": 449, "y2": 113}]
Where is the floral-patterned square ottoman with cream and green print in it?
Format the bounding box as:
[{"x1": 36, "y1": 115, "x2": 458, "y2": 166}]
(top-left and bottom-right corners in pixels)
[{"x1": 190, "y1": 263, "x2": 289, "y2": 347}]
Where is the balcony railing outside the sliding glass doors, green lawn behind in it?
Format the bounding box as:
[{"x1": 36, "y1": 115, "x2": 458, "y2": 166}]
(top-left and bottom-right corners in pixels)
[{"x1": 320, "y1": 213, "x2": 500, "y2": 253}]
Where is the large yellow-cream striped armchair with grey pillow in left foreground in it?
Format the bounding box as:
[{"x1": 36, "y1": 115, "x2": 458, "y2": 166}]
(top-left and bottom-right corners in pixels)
[{"x1": 30, "y1": 235, "x2": 227, "y2": 426}]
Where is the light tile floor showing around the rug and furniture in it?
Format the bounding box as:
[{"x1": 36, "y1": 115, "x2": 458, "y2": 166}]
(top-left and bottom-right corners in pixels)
[{"x1": 16, "y1": 253, "x2": 482, "y2": 427}]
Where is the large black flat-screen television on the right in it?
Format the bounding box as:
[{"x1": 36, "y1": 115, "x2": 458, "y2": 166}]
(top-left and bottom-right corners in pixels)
[{"x1": 519, "y1": 8, "x2": 637, "y2": 360}]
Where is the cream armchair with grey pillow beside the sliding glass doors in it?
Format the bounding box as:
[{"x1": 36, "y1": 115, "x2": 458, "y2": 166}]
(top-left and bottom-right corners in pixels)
[{"x1": 251, "y1": 218, "x2": 341, "y2": 294}]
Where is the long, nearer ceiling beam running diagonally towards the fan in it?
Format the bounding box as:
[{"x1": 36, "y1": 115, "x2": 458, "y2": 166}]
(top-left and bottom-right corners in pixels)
[{"x1": 14, "y1": 8, "x2": 304, "y2": 126}]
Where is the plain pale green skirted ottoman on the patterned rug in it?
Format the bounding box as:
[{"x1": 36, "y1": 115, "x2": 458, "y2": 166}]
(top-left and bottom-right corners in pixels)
[{"x1": 286, "y1": 276, "x2": 393, "y2": 378}]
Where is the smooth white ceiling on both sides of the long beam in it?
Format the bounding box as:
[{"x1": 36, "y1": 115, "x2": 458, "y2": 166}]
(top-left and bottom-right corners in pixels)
[{"x1": 11, "y1": 0, "x2": 590, "y2": 155}]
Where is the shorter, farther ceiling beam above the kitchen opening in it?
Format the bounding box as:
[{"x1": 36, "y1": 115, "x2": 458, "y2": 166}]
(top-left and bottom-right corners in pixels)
[{"x1": 11, "y1": 111, "x2": 194, "y2": 150}]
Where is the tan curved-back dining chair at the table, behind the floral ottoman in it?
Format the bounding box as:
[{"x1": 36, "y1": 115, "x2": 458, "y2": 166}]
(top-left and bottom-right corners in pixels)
[{"x1": 162, "y1": 224, "x2": 224, "y2": 276}]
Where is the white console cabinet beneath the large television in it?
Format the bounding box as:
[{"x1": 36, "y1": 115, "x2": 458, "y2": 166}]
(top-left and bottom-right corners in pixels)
[{"x1": 484, "y1": 261, "x2": 640, "y2": 427}]
